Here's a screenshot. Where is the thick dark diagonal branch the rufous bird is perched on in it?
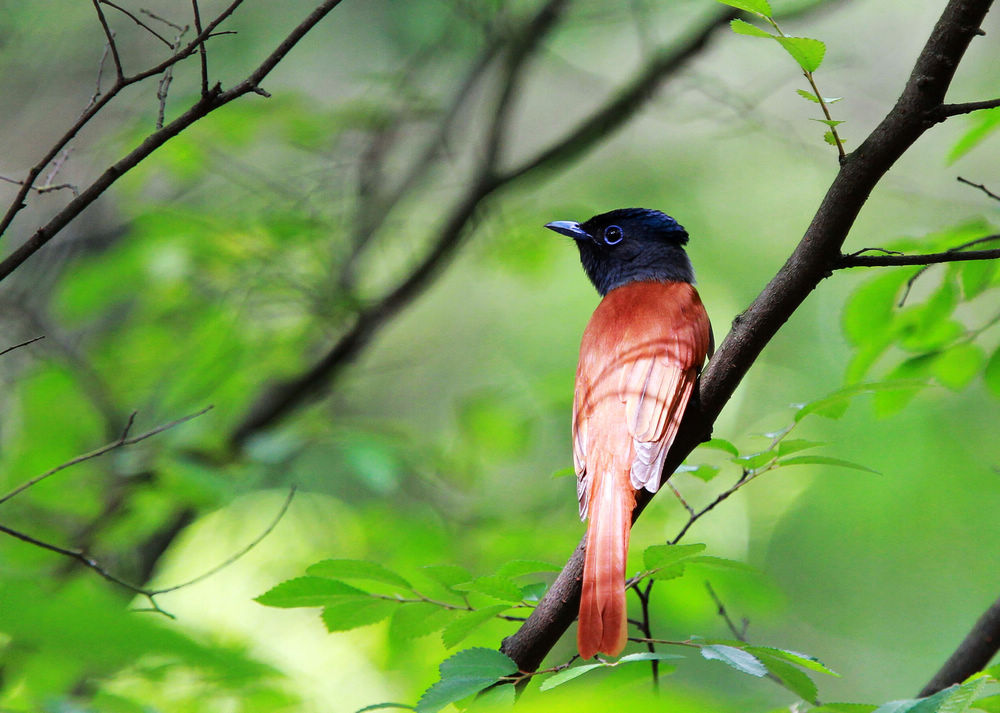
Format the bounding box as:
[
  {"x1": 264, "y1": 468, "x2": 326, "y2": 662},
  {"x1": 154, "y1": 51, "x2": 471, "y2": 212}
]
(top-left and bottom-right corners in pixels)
[{"x1": 501, "y1": 0, "x2": 992, "y2": 671}]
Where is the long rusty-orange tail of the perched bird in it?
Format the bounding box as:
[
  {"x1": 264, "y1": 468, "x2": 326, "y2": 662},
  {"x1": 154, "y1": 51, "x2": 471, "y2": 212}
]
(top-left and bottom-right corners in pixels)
[{"x1": 576, "y1": 473, "x2": 635, "y2": 659}]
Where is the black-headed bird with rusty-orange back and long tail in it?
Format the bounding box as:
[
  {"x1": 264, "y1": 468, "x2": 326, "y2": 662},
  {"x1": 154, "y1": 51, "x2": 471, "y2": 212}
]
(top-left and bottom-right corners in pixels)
[{"x1": 545, "y1": 208, "x2": 714, "y2": 659}]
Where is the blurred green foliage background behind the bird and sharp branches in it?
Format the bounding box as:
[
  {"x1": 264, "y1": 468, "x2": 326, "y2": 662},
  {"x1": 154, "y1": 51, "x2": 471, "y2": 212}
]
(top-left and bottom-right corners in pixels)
[{"x1": 0, "y1": 0, "x2": 1000, "y2": 711}]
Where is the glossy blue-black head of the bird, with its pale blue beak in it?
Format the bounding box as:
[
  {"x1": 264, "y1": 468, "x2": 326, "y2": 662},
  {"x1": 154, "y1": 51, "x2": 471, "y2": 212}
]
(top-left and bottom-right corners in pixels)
[{"x1": 545, "y1": 208, "x2": 694, "y2": 295}]
